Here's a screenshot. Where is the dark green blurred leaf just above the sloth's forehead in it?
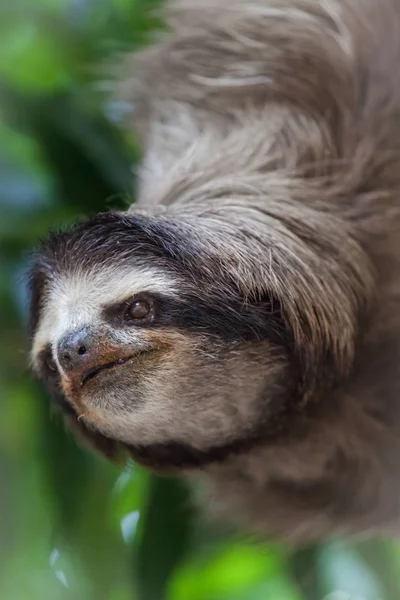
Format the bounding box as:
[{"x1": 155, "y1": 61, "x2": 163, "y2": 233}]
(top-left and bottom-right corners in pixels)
[{"x1": 3, "y1": 90, "x2": 135, "y2": 212}]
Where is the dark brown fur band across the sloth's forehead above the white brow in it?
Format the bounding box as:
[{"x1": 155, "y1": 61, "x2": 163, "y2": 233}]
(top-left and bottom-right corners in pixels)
[{"x1": 28, "y1": 213, "x2": 199, "y2": 337}]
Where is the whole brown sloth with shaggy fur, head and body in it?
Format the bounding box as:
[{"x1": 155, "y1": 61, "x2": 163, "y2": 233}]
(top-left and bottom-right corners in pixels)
[{"x1": 30, "y1": 0, "x2": 400, "y2": 543}]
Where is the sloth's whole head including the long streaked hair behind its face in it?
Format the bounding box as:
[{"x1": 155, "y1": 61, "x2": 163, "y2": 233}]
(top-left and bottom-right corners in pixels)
[{"x1": 31, "y1": 213, "x2": 372, "y2": 471}]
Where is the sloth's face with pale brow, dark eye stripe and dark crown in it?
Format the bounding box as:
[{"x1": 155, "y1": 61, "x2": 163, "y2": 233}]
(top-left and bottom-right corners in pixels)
[{"x1": 27, "y1": 214, "x2": 294, "y2": 470}]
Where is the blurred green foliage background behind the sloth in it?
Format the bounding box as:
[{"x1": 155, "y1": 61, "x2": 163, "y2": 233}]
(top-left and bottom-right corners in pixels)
[{"x1": 0, "y1": 0, "x2": 400, "y2": 600}]
